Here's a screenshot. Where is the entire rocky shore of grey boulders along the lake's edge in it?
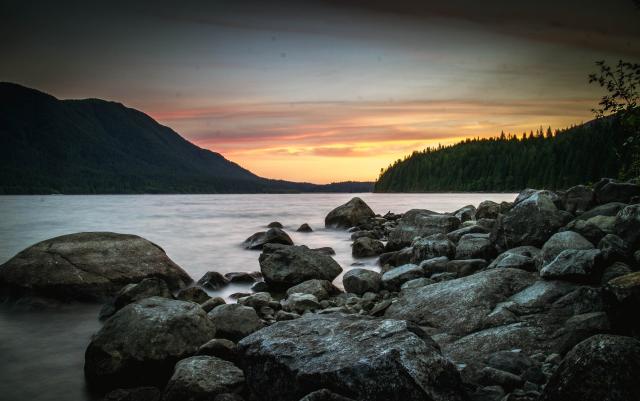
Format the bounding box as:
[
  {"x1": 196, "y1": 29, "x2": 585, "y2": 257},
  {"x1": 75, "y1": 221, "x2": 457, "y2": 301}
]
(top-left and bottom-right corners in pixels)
[{"x1": 0, "y1": 179, "x2": 640, "y2": 401}]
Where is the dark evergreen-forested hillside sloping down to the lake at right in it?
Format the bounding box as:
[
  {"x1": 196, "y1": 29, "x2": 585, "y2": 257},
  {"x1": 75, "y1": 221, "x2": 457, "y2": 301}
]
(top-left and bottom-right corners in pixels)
[{"x1": 374, "y1": 118, "x2": 625, "y2": 192}]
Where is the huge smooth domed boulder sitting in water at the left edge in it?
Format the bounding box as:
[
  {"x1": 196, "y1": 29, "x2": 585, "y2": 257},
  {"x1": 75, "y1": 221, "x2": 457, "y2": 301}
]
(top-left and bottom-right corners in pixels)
[{"x1": 0, "y1": 232, "x2": 192, "y2": 301}]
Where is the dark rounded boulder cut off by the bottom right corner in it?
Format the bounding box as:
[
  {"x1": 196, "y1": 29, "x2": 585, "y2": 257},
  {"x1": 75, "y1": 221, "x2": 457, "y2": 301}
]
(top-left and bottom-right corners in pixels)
[{"x1": 540, "y1": 335, "x2": 640, "y2": 401}]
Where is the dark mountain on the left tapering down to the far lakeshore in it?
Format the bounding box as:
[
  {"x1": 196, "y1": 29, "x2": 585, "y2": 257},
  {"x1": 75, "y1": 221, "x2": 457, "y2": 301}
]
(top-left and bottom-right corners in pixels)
[{"x1": 0, "y1": 83, "x2": 372, "y2": 194}]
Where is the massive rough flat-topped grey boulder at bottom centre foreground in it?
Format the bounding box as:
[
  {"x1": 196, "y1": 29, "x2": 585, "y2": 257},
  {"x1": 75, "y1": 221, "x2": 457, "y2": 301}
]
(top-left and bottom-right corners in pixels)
[{"x1": 238, "y1": 314, "x2": 465, "y2": 401}]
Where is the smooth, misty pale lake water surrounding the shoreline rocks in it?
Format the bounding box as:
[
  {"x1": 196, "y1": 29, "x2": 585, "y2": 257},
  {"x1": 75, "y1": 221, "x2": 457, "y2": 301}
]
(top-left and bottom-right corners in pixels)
[{"x1": 0, "y1": 193, "x2": 516, "y2": 401}]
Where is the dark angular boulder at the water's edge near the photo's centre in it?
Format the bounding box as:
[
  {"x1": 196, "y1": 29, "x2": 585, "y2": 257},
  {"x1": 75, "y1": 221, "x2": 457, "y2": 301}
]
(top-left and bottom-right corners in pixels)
[{"x1": 259, "y1": 245, "x2": 342, "y2": 289}]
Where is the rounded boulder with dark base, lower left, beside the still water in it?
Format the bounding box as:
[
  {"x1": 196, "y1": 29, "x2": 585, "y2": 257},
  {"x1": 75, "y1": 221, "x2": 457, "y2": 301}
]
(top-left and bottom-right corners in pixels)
[{"x1": 84, "y1": 297, "x2": 216, "y2": 388}]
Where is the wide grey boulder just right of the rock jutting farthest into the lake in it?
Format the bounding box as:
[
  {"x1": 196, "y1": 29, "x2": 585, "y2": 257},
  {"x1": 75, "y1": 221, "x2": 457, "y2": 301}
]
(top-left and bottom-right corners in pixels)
[{"x1": 389, "y1": 209, "x2": 460, "y2": 249}]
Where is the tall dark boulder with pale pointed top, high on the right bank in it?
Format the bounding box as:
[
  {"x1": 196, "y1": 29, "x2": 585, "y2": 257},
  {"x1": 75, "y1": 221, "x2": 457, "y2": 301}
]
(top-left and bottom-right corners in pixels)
[{"x1": 491, "y1": 191, "x2": 571, "y2": 251}]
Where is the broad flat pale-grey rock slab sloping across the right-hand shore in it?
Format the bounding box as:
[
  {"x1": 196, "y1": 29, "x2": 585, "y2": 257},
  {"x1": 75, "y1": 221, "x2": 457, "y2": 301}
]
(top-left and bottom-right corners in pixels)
[{"x1": 385, "y1": 269, "x2": 535, "y2": 335}]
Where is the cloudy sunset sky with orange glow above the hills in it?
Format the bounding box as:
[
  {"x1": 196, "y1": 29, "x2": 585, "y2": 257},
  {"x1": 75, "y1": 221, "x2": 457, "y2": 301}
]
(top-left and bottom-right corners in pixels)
[{"x1": 0, "y1": 0, "x2": 640, "y2": 183}]
